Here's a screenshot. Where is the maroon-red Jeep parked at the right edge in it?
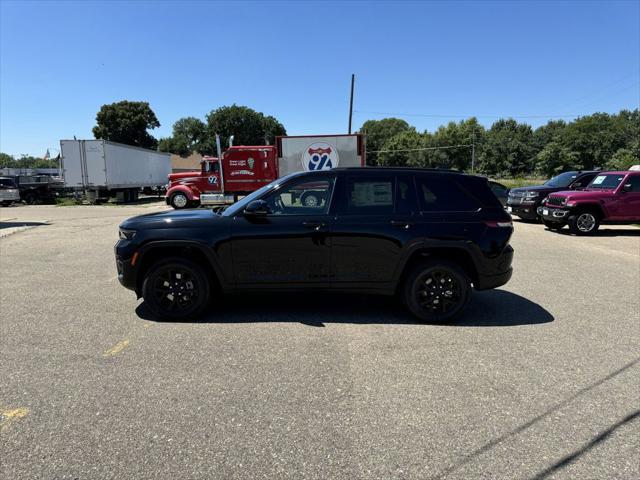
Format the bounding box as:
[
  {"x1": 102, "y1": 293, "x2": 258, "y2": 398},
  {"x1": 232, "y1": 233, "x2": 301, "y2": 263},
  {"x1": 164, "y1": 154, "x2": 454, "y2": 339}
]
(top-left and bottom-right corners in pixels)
[{"x1": 538, "y1": 171, "x2": 640, "y2": 235}]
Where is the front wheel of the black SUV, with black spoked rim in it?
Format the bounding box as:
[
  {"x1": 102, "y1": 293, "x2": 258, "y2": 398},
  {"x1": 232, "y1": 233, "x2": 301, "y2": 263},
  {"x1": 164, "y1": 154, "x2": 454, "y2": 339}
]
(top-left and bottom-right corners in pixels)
[{"x1": 142, "y1": 257, "x2": 211, "y2": 320}]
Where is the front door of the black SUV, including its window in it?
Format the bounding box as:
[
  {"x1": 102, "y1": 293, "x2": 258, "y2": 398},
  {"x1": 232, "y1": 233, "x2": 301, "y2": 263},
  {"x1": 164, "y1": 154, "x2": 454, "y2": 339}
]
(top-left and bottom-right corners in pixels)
[{"x1": 232, "y1": 174, "x2": 335, "y2": 287}]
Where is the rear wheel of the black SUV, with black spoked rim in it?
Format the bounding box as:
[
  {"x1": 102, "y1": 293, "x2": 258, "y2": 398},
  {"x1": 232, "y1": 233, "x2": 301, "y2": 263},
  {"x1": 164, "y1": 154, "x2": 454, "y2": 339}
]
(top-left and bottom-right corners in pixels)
[{"x1": 402, "y1": 259, "x2": 471, "y2": 323}]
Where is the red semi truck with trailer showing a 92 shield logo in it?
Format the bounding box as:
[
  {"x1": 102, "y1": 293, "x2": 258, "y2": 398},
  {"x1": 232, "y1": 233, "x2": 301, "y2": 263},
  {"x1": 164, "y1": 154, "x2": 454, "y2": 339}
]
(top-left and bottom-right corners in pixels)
[{"x1": 166, "y1": 134, "x2": 365, "y2": 209}]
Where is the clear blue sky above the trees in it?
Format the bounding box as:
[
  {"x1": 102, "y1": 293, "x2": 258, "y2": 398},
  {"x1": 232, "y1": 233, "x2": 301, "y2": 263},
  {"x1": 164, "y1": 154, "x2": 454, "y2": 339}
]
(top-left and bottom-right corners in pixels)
[{"x1": 0, "y1": 0, "x2": 640, "y2": 156}]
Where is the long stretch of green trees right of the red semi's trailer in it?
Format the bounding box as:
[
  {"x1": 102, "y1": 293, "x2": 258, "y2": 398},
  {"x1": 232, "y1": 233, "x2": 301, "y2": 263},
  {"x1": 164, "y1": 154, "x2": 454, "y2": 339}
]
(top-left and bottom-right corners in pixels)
[{"x1": 360, "y1": 109, "x2": 640, "y2": 177}]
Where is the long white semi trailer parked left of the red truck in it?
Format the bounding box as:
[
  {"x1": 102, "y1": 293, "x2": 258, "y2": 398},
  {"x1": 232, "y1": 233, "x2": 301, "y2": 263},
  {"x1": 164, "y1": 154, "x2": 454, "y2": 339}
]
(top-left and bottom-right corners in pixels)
[{"x1": 60, "y1": 140, "x2": 171, "y2": 201}]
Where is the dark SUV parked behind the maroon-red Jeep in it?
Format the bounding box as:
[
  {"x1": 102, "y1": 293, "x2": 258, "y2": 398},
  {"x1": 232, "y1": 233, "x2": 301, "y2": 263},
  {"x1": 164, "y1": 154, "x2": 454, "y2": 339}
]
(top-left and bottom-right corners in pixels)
[{"x1": 507, "y1": 171, "x2": 598, "y2": 220}]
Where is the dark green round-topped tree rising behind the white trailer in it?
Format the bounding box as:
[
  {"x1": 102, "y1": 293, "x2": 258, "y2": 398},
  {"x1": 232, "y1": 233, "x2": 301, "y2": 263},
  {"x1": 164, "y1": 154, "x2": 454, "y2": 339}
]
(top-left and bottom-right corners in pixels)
[{"x1": 93, "y1": 100, "x2": 160, "y2": 148}]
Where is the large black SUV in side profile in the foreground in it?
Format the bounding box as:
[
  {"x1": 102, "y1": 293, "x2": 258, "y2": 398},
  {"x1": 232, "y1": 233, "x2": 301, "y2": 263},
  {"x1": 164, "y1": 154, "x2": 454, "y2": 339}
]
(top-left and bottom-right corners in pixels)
[{"x1": 115, "y1": 168, "x2": 513, "y2": 322}]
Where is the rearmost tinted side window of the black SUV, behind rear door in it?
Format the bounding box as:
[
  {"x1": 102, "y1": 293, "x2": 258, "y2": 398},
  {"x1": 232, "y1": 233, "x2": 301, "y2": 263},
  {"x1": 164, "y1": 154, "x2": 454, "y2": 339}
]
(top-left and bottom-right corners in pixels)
[{"x1": 417, "y1": 174, "x2": 482, "y2": 212}]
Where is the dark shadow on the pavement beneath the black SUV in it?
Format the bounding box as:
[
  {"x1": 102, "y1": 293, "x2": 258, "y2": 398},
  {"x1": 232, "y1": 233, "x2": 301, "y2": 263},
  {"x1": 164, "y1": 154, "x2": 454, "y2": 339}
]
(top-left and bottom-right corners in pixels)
[{"x1": 136, "y1": 290, "x2": 553, "y2": 327}]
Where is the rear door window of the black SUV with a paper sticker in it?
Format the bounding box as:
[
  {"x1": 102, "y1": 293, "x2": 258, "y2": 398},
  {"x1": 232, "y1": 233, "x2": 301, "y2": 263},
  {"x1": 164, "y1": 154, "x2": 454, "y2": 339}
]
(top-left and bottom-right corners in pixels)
[{"x1": 346, "y1": 177, "x2": 394, "y2": 215}]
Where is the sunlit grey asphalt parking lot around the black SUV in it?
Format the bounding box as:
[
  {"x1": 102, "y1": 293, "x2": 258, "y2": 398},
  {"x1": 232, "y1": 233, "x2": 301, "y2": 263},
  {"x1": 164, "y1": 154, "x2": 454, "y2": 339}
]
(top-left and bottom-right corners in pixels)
[{"x1": 0, "y1": 203, "x2": 640, "y2": 480}]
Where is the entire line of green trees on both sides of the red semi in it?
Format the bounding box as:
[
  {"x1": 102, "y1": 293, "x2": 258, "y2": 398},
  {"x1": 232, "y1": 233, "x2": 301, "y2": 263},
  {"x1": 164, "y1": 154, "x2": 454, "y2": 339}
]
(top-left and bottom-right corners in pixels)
[{"x1": 0, "y1": 100, "x2": 640, "y2": 177}]
